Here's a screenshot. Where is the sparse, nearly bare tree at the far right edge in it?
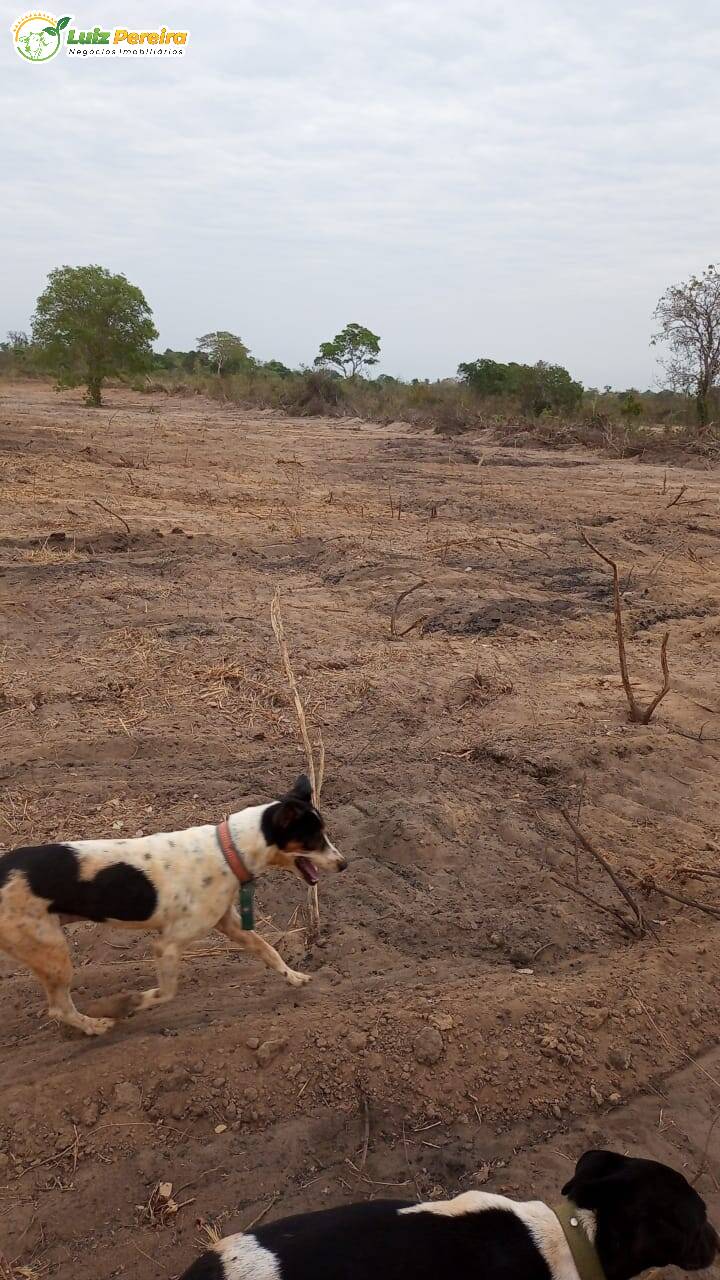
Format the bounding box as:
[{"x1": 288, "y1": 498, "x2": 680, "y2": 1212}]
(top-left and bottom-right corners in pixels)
[{"x1": 651, "y1": 264, "x2": 720, "y2": 428}]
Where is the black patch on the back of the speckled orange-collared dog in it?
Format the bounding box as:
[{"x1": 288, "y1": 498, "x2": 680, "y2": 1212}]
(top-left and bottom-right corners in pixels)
[{"x1": 0, "y1": 845, "x2": 158, "y2": 922}]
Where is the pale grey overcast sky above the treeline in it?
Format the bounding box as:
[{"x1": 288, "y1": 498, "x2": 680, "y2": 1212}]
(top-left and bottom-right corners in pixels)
[{"x1": 0, "y1": 0, "x2": 720, "y2": 387}]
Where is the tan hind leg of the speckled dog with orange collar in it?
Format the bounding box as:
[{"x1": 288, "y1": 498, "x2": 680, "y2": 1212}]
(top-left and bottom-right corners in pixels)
[{"x1": 0, "y1": 915, "x2": 113, "y2": 1036}]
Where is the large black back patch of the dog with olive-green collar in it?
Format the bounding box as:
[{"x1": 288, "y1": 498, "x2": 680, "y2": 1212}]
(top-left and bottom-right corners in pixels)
[{"x1": 249, "y1": 1201, "x2": 552, "y2": 1280}]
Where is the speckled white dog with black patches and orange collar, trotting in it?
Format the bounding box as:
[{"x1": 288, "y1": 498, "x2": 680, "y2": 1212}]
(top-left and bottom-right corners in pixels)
[{"x1": 0, "y1": 774, "x2": 347, "y2": 1036}]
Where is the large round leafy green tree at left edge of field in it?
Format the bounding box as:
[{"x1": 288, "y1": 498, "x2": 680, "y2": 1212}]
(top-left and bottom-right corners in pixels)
[{"x1": 32, "y1": 266, "x2": 158, "y2": 404}]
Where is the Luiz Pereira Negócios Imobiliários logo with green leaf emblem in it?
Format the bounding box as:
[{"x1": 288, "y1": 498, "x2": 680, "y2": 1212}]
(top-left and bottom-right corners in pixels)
[{"x1": 13, "y1": 13, "x2": 190, "y2": 63}]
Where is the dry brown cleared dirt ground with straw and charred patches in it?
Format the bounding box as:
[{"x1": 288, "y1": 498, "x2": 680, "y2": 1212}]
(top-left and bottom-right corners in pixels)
[{"x1": 0, "y1": 383, "x2": 720, "y2": 1280}]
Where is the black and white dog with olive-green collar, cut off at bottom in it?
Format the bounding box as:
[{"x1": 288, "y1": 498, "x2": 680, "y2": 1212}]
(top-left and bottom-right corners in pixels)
[{"x1": 182, "y1": 1151, "x2": 719, "y2": 1280}]
